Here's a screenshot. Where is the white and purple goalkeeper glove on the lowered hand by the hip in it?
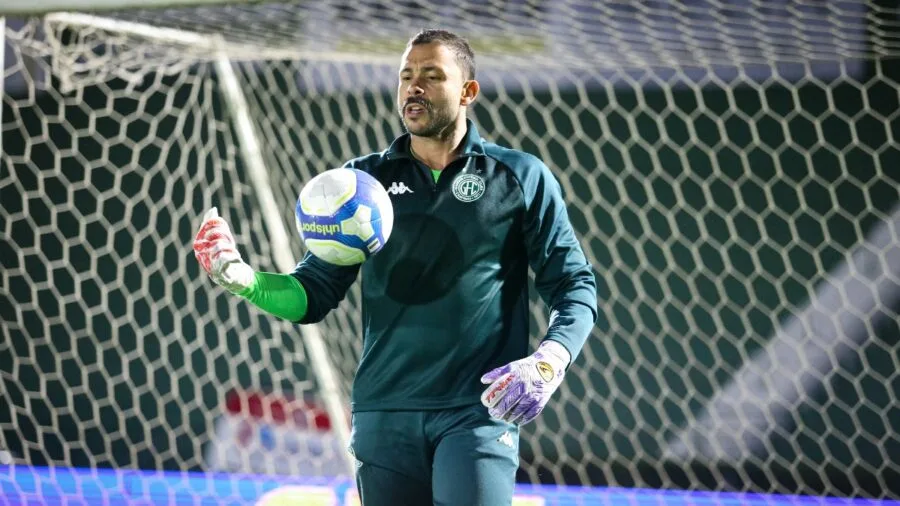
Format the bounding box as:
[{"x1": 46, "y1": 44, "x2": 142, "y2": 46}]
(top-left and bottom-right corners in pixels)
[{"x1": 481, "y1": 340, "x2": 571, "y2": 425}]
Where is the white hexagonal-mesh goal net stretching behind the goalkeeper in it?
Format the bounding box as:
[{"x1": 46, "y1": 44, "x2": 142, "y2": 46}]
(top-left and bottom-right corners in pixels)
[{"x1": 0, "y1": 0, "x2": 900, "y2": 497}]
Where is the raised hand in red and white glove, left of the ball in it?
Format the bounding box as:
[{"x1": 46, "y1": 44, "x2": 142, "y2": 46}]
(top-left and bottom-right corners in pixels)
[{"x1": 194, "y1": 207, "x2": 253, "y2": 293}]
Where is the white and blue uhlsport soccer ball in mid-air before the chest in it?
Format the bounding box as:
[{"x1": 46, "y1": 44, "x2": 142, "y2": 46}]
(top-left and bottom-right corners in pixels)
[{"x1": 295, "y1": 169, "x2": 394, "y2": 265}]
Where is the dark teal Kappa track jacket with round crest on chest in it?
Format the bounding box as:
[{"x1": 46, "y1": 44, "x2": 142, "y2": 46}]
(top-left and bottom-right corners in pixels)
[{"x1": 293, "y1": 121, "x2": 597, "y2": 411}]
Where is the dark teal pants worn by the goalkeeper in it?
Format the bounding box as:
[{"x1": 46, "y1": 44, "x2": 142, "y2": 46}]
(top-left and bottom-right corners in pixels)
[{"x1": 350, "y1": 404, "x2": 519, "y2": 506}]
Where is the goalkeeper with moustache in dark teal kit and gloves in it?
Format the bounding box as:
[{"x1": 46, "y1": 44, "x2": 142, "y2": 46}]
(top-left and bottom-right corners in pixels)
[{"x1": 194, "y1": 30, "x2": 597, "y2": 506}]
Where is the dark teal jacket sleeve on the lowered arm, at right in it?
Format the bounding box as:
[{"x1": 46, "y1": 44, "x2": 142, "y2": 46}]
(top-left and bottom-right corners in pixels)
[{"x1": 522, "y1": 158, "x2": 597, "y2": 361}]
